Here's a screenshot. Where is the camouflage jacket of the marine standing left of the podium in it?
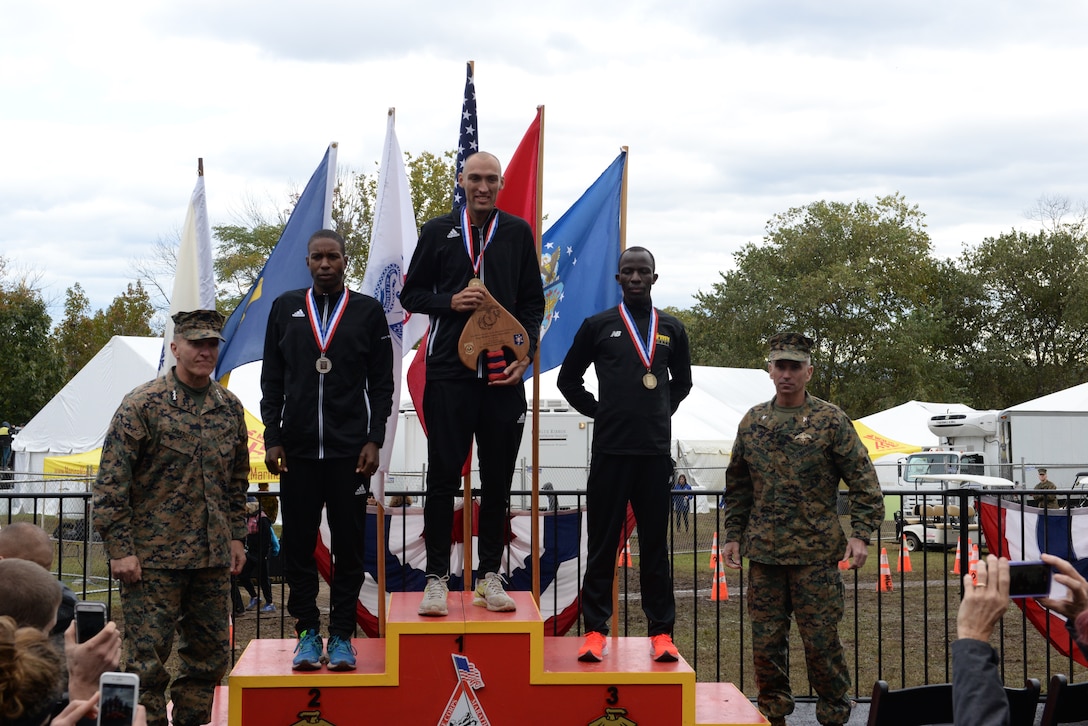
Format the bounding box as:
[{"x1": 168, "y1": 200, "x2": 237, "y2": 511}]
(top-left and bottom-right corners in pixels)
[{"x1": 94, "y1": 370, "x2": 249, "y2": 569}]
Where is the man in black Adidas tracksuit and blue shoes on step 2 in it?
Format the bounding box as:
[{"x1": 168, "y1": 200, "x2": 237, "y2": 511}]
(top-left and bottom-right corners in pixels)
[{"x1": 261, "y1": 230, "x2": 393, "y2": 669}]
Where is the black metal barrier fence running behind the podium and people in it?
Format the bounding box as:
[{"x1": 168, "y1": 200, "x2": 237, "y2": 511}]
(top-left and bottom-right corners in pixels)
[{"x1": 0, "y1": 471, "x2": 1088, "y2": 701}]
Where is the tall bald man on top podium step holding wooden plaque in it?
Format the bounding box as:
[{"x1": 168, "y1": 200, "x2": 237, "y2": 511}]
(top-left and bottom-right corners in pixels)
[{"x1": 400, "y1": 151, "x2": 544, "y2": 616}]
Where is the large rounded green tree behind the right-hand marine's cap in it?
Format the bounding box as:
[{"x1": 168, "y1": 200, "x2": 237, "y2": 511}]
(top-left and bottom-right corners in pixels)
[{"x1": 690, "y1": 195, "x2": 961, "y2": 416}]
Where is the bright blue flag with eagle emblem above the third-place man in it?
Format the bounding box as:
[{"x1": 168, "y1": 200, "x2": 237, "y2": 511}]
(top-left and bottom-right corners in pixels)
[{"x1": 527, "y1": 151, "x2": 627, "y2": 376}]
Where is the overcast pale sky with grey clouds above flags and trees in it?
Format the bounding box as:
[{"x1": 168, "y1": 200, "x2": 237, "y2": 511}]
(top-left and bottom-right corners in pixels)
[{"x1": 0, "y1": 0, "x2": 1088, "y2": 320}]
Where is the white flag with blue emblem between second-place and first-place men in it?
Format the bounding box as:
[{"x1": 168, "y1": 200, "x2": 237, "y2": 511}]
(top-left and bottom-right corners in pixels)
[{"x1": 362, "y1": 109, "x2": 417, "y2": 502}]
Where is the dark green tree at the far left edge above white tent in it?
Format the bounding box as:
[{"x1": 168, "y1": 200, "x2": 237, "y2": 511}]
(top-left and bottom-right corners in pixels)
[{"x1": 0, "y1": 258, "x2": 64, "y2": 424}]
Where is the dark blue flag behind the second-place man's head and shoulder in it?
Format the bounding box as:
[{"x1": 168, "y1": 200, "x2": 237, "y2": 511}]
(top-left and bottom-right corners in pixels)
[{"x1": 215, "y1": 144, "x2": 336, "y2": 379}]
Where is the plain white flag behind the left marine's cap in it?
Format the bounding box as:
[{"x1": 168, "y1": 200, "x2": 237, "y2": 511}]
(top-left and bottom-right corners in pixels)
[{"x1": 159, "y1": 174, "x2": 215, "y2": 376}]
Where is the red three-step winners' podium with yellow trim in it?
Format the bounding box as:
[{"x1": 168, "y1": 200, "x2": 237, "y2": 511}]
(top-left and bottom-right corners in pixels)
[{"x1": 214, "y1": 592, "x2": 767, "y2": 726}]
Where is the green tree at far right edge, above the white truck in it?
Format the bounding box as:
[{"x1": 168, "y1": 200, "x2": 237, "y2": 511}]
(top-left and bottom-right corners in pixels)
[{"x1": 960, "y1": 222, "x2": 1088, "y2": 407}]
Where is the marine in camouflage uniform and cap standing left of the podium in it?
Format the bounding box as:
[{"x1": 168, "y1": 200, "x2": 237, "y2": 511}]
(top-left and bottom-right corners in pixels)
[{"x1": 94, "y1": 310, "x2": 249, "y2": 726}]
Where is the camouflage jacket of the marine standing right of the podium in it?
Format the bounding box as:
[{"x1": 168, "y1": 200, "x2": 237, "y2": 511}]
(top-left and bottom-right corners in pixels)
[{"x1": 725, "y1": 394, "x2": 883, "y2": 565}]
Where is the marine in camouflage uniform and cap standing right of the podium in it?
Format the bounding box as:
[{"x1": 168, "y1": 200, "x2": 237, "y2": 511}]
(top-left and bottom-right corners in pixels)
[{"x1": 722, "y1": 333, "x2": 883, "y2": 726}]
